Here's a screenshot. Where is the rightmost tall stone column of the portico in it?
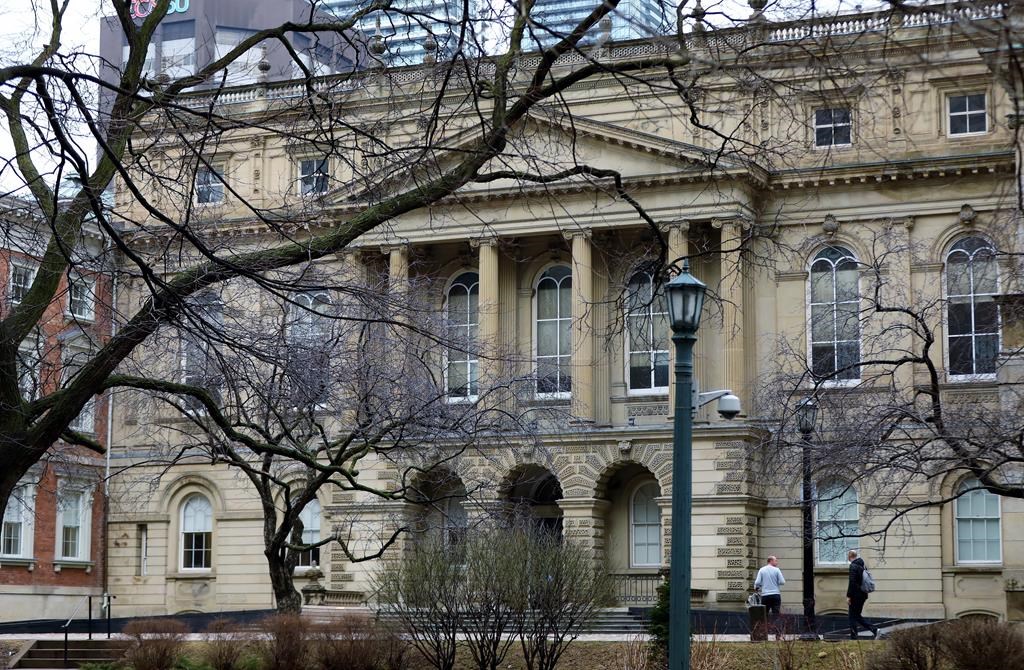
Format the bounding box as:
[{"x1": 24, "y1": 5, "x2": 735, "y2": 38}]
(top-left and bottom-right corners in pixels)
[{"x1": 713, "y1": 218, "x2": 750, "y2": 412}]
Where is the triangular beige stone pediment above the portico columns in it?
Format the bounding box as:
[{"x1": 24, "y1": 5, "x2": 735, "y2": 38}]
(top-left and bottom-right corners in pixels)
[{"x1": 328, "y1": 110, "x2": 746, "y2": 205}]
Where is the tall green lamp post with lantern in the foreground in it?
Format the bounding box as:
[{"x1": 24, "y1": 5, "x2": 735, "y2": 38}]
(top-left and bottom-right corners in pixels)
[{"x1": 665, "y1": 261, "x2": 708, "y2": 670}]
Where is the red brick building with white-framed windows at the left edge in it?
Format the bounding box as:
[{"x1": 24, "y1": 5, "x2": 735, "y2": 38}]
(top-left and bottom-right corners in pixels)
[{"x1": 0, "y1": 198, "x2": 112, "y2": 620}]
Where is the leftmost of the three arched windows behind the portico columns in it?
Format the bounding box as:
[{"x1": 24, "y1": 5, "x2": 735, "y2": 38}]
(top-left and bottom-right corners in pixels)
[{"x1": 444, "y1": 273, "x2": 480, "y2": 400}]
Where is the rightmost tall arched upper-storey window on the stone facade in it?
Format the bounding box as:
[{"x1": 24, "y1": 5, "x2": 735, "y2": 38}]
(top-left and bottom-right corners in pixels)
[{"x1": 946, "y1": 238, "x2": 999, "y2": 376}]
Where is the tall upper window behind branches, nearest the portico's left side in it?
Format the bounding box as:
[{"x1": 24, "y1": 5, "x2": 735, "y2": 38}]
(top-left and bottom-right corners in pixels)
[{"x1": 286, "y1": 291, "x2": 332, "y2": 408}]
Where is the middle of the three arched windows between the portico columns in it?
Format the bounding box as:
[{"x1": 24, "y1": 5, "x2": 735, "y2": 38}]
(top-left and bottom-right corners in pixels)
[{"x1": 535, "y1": 265, "x2": 572, "y2": 394}]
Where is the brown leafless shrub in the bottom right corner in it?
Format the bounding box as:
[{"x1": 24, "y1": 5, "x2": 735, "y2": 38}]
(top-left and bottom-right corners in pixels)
[{"x1": 929, "y1": 619, "x2": 1024, "y2": 670}]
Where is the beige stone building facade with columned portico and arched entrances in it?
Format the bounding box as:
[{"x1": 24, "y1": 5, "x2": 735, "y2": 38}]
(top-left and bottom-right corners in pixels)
[{"x1": 101, "y1": 3, "x2": 1024, "y2": 620}]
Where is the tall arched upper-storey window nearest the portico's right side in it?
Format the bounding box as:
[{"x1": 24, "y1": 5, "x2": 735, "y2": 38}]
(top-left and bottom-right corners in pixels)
[{"x1": 810, "y1": 247, "x2": 860, "y2": 380}]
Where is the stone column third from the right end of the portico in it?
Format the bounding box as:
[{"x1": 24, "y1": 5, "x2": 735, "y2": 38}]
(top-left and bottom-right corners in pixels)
[{"x1": 565, "y1": 229, "x2": 594, "y2": 422}]
